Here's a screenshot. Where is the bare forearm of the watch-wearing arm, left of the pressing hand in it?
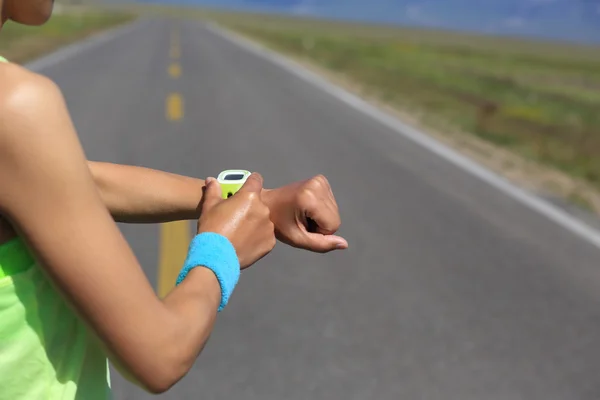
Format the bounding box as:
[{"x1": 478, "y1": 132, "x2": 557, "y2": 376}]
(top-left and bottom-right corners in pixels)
[{"x1": 88, "y1": 161, "x2": 204, "y2": 223}]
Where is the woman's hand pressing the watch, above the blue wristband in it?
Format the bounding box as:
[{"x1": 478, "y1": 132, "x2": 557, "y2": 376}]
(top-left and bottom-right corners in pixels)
[{"x1": 198, "y1": 173, "x2": 276, "y2": 269}]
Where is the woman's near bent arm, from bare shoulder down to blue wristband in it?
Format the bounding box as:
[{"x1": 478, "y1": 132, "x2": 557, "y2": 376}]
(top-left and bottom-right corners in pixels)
[{"x1": 0, "y1": 67, "x2": 234, "y2": 392}]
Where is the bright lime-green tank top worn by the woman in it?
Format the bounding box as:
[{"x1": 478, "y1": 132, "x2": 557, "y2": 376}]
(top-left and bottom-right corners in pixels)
[{"x1": 0, "y1": 59, "x2": 111, "y2": 400}]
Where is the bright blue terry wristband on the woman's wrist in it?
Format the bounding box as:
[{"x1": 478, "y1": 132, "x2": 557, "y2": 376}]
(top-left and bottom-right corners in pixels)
[{"x1": 175, "y1": 232, "x2": 240, "y2": 311}]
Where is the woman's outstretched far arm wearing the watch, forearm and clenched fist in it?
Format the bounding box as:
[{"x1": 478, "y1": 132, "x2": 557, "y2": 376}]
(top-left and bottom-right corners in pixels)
[{"x1": 88, "y1": 161, "x2": 348, "y2": 253}]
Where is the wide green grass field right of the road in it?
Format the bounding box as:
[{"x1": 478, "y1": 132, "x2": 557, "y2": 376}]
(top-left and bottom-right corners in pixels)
[{"x1": 203, "y1": 12, "x2": 600, "y2": 188}]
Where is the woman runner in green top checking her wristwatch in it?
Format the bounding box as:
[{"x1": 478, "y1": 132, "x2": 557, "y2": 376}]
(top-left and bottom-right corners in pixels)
[{"x1": 0, "y1": 0, "x2": 348, "y2": 400}]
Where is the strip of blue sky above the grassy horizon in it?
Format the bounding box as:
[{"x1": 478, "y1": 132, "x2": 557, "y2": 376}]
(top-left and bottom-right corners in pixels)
[{"x1": 138, "y1": 0, "x2": 600, "y2": 43}]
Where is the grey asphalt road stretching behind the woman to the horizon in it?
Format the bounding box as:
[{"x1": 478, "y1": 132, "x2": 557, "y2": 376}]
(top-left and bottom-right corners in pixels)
[{"x1": 34, "y1": 19, "x2": 600, "y2": 400}]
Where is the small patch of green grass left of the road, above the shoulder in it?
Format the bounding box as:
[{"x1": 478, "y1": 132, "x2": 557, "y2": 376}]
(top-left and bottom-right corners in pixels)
[{"x1": 0, "y1": 9, "x2": 135, "y2": 63}]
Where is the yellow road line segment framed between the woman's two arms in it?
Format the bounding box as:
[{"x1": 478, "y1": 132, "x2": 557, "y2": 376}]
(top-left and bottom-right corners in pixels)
[{"x1": 157, "y1": 221, "x2": 191, "y2": 298}]
